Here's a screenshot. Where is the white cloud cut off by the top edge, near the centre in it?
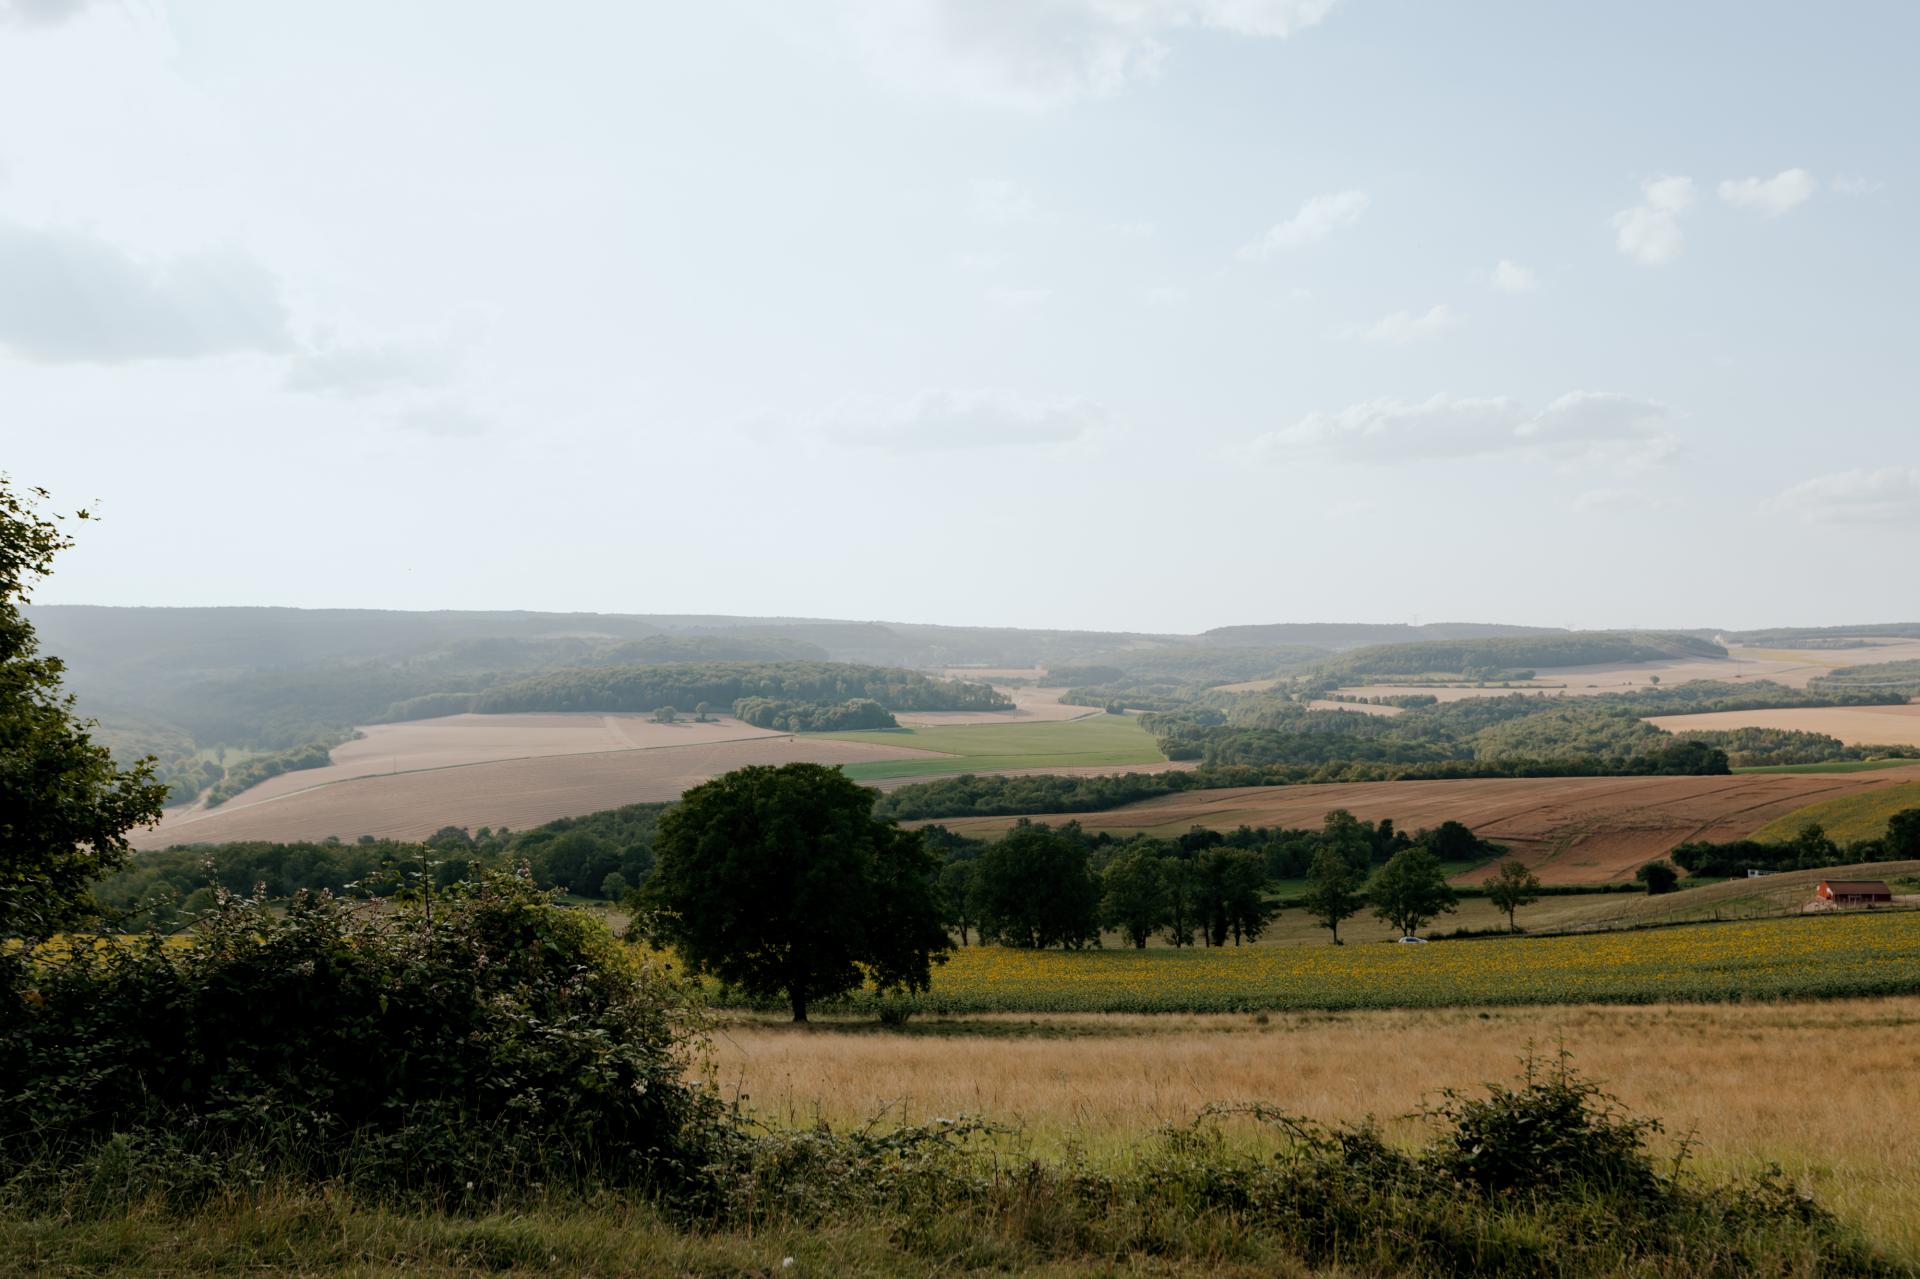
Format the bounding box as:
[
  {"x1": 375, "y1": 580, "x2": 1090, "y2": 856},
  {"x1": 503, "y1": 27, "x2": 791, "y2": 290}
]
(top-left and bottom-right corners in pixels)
[{"x1": 841, "y1": 0, "x2": 1338, "y2": 108}]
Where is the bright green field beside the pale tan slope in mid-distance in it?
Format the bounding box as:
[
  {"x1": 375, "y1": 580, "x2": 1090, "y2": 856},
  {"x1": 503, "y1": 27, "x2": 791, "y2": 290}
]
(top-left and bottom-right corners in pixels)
[{"x1": 820, "y1": 714, "x2": 1165, "y2": 782}]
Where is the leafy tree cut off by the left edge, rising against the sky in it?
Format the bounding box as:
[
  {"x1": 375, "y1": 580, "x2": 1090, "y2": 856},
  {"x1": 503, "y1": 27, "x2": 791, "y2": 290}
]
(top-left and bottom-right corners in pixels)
[{"x1": 0, "y1": 476, "x2": 167, "y2": 937}]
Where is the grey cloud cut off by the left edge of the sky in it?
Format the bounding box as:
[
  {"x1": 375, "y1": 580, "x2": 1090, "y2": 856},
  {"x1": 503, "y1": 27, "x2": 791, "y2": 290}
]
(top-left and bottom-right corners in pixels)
[{"x1": 0, "y1": 223, "x2": 288, "y2": 363}]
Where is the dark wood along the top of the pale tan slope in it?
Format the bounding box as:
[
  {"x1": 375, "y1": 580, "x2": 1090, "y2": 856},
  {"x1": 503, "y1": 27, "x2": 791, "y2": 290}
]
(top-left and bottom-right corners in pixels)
[{"x1": 470, "y1": 663, "x2": 1014, "y2": 714}]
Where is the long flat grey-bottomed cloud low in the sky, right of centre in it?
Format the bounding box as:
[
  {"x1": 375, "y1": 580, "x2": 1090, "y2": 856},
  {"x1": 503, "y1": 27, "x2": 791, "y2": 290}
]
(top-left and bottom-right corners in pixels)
[{"x1": 1248, "y1": 392, "x2": 1678, "y2": 467}]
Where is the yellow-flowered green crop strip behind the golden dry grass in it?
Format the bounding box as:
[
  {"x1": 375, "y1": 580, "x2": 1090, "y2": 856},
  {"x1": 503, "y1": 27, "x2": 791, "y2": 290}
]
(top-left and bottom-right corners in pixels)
[{"x1": 768, "y1": 908, "x2": 1920, "y2": 1014}]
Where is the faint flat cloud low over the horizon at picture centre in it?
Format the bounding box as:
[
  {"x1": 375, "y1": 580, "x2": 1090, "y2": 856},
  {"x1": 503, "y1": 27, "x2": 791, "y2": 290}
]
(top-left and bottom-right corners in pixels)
[{"x1": 812, "y1": 390, "x2": 1110, "y2": 451}]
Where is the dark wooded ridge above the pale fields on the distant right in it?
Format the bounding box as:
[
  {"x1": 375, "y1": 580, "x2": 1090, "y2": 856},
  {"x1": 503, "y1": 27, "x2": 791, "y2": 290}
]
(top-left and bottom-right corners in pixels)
[{"x1": 1313, "y1": 630, "x2": 1726, "y2": 684}]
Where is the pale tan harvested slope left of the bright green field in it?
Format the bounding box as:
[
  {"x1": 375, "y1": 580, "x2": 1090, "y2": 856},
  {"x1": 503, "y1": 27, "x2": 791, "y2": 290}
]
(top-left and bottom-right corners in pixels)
[{"x1": 134, "y1": 734, "x2": 931, "y2": 849}]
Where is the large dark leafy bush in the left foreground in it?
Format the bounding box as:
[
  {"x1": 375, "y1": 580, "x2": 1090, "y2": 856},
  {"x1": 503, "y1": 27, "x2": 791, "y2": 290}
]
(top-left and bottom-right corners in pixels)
[{"x1": 0, "y1": 868, "x2": 718, "y2": 1196}]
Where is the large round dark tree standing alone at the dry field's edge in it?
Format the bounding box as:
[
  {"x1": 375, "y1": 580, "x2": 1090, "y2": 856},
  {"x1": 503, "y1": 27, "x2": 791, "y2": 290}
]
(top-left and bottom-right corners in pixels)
[{"x1": 643, "y1": 764, "x2": 952, "y2": 1022}]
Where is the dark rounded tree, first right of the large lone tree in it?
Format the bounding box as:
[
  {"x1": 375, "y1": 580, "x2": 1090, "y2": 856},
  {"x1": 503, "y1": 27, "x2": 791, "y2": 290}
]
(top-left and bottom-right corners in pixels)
[{"x1": 975, "y1": 820, "x2": 1100, "y2": 951}]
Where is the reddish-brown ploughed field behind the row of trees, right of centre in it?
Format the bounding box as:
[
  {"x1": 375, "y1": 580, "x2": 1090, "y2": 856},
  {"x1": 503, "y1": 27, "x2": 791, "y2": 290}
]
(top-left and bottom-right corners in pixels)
[{"x1": 943, "y1": 766, "x2": 1920, "y2": 883}]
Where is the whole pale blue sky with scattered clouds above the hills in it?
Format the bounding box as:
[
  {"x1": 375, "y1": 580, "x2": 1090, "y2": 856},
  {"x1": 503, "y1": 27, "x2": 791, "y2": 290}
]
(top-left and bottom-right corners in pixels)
[{"x1": 0, "y1": 0, "x2": 1920, "y2": 632}]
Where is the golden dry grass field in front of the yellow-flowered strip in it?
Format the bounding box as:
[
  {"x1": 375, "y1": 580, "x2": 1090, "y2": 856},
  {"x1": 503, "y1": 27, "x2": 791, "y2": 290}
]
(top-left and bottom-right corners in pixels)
[{"x1": 716, "y1": 997, "x2": 1920, "y2": 1262}]
